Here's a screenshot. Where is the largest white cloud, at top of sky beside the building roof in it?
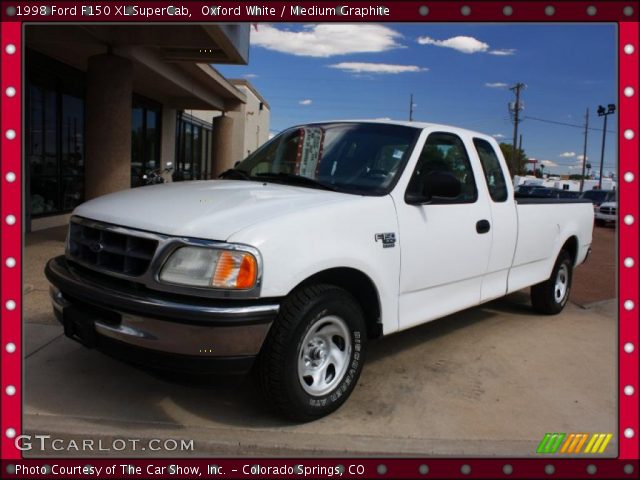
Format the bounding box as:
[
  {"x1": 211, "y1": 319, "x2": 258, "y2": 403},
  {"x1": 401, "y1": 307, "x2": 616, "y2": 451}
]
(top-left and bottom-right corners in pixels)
[{"x1": 251, "y1": 23, "x2": 402, "y2": 57}]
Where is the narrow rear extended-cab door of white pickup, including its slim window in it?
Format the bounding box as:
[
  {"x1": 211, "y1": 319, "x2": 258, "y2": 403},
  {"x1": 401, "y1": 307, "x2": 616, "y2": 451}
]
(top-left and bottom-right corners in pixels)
[{"x1": 473, "y1": 137, "x2": 518, "y2": 302}]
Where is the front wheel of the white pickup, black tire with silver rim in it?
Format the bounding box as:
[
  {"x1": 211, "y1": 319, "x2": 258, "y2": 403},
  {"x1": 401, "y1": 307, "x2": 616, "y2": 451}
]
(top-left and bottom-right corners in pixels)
[{"x1": 257, "y1": 284, "x2": 367, "y2": 421}]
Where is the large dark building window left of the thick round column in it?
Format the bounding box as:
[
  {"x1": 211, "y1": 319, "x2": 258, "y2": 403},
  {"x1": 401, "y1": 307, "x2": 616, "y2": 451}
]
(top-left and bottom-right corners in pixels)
[{"x1": 25, "y1": 51, "x2": 85, "y2": 217}]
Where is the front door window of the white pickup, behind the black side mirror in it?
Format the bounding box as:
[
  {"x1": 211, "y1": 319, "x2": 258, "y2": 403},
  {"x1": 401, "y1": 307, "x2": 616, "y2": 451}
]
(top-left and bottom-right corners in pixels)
[{"x1": 407, "y1": 132, "x2": 478, "y2": 204}]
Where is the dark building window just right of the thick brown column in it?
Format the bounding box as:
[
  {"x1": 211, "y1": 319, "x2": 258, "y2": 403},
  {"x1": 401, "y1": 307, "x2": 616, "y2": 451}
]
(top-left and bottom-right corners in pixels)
[{"x1": 131, "y1": 95, "x2": 162, "y2": 187}]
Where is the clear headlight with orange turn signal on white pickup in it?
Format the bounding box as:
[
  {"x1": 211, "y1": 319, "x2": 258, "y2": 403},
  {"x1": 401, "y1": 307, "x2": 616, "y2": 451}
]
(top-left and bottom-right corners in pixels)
[{"x1": 160, "y1": 247, "x2": 258, "y2": 290}]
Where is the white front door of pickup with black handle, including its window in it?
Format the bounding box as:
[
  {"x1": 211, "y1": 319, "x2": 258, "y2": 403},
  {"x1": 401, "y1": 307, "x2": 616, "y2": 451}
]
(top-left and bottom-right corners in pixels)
[{"x1": 394, "y1": 132, "x2": 492, "y2": 329}]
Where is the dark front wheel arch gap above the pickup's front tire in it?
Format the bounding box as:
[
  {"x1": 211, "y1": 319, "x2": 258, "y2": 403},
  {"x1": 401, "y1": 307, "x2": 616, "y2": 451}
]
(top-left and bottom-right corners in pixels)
[{"x1": 294, "y1": 267, "x2": 382, "y2": 338}]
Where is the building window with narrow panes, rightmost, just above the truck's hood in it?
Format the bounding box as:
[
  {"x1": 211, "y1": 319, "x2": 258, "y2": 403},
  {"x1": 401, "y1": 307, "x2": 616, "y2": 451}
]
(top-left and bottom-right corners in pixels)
[{"x1": 173, "y1": 113, "x2": 212, "y2": 181}]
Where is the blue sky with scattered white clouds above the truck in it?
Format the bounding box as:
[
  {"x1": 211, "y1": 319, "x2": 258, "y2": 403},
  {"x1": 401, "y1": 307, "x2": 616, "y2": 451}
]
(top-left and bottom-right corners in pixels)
[{"x1": 215, "y1": 23, "x2": 618, "y2": 176}]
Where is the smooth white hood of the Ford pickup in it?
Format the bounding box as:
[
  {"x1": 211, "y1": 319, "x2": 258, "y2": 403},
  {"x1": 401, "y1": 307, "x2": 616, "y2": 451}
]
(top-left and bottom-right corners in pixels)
[{"x1": 73, "y1": 180, "x2": 354, "y2": 241}]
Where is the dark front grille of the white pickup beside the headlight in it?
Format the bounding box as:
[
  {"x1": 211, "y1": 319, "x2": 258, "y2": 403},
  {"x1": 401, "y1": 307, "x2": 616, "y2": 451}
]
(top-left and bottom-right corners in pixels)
[{"x1": 68, "y1": 221, "x2": 158, "y2": 277}]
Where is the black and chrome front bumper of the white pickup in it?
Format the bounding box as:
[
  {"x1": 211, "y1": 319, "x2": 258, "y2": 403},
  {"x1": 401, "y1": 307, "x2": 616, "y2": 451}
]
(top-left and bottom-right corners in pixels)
[{"x1": 45, "y1": 256, "x2": 280, "y2": 373}]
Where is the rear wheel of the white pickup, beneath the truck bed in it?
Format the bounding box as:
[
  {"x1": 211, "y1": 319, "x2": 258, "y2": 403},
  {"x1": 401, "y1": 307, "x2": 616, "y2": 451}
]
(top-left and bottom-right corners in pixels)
[{"x1": 531, "y1": 250, "x2": 573, "y2": 315}]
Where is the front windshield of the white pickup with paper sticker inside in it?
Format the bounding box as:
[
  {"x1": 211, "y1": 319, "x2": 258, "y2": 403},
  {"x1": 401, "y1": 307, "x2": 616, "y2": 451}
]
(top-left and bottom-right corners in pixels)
[{"x1": 230, "y1": 123, "x2": 420, "y2": 195}]
